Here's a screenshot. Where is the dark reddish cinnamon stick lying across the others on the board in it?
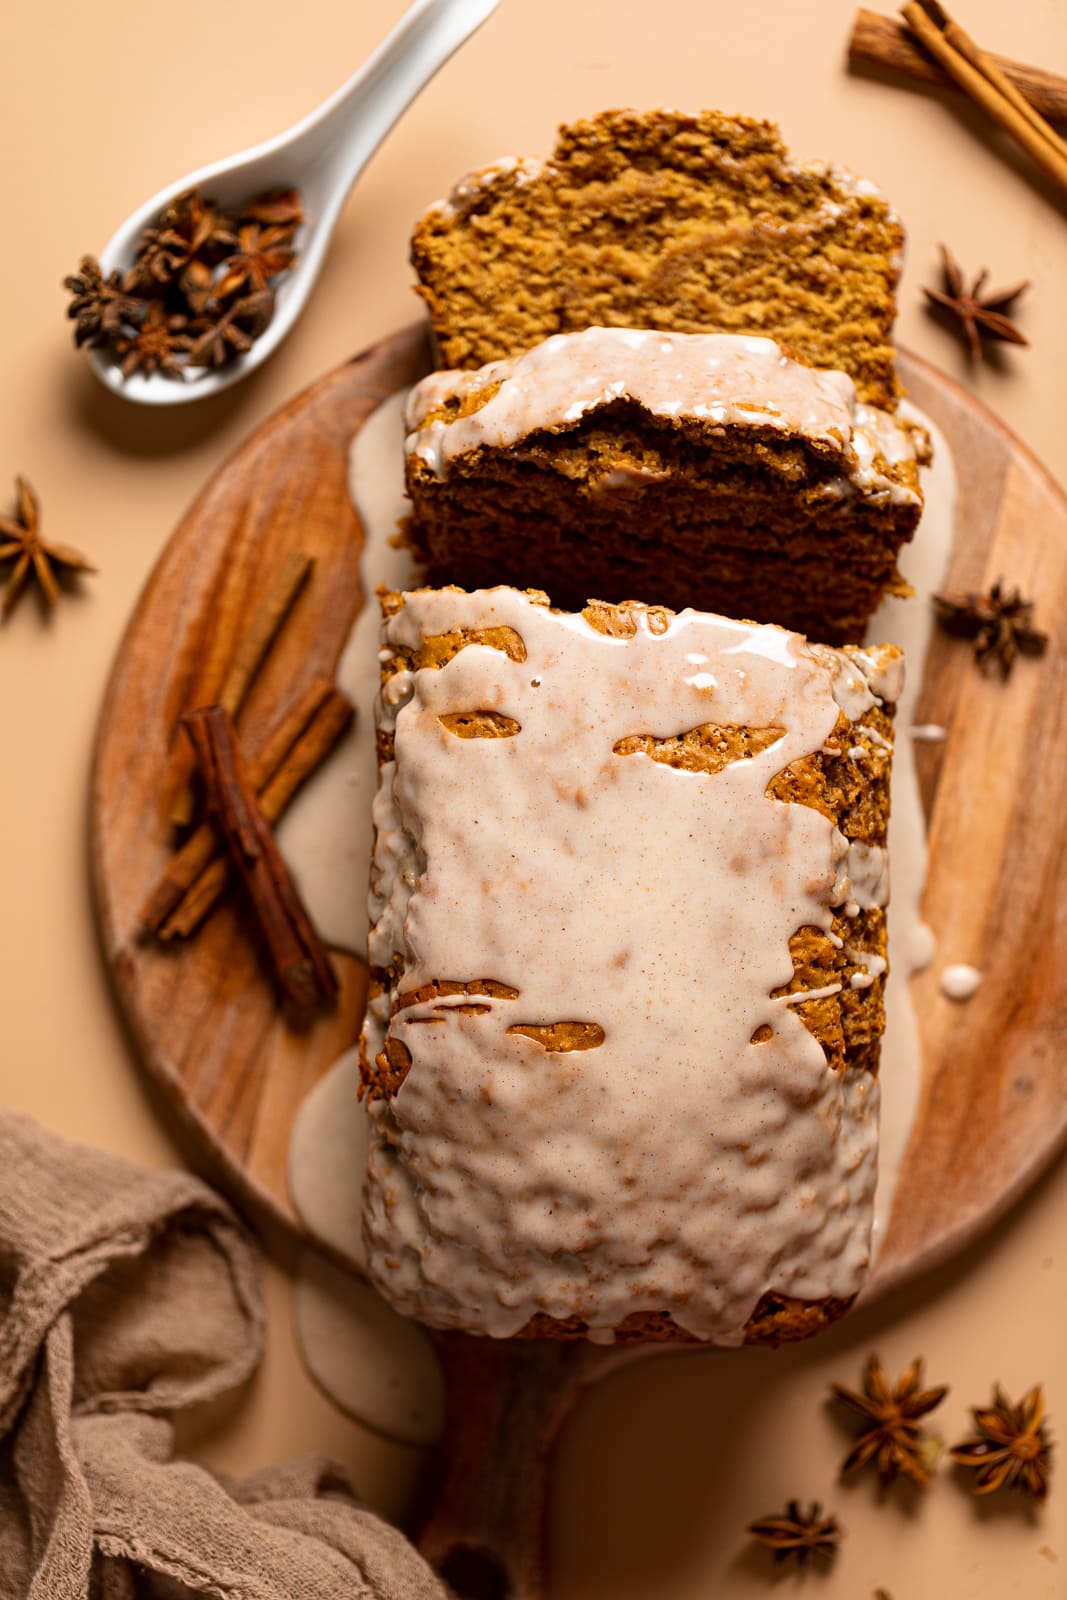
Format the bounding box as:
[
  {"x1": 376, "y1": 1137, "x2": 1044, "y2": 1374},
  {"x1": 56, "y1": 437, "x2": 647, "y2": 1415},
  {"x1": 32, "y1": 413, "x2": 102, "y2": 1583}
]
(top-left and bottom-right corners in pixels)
[{"x1": 182, "y1": 706, "x2": 338, "y2": 1011}]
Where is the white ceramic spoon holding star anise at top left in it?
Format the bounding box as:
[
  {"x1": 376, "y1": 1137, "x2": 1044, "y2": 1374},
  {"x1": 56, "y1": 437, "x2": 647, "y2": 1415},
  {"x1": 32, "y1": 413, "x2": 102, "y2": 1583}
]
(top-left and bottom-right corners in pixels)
[{"x1": 88, "y1": 0, "x2": 499, "y2": 405}]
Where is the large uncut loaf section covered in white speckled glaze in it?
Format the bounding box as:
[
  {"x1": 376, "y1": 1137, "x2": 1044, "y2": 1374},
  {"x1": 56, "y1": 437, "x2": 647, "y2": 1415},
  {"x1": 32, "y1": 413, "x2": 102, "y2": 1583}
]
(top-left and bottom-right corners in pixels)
[{"x1": 362, "y1": 587, "x2": 901, "y2": 1346}]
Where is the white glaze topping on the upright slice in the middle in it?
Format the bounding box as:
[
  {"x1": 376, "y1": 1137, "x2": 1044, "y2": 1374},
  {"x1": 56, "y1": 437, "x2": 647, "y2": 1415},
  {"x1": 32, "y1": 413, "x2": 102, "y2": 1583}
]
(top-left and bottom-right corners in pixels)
[{"x1": 406, "y1": 328, "x2": 918, "y2": 504}]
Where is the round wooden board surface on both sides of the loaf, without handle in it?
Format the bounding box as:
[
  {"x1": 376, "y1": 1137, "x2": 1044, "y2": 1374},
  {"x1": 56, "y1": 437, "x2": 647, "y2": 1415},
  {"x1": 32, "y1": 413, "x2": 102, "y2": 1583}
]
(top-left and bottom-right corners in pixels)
[{"x1": 91, "y1": 326, "x2": 1067, "y2": 1286}]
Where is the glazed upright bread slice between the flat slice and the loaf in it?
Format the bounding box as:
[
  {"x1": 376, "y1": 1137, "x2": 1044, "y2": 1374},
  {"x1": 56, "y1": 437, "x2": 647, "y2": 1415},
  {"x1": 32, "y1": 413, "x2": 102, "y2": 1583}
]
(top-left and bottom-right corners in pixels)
[{"x1": 406, "y1": 328, "x2": 923, "y2": 645}]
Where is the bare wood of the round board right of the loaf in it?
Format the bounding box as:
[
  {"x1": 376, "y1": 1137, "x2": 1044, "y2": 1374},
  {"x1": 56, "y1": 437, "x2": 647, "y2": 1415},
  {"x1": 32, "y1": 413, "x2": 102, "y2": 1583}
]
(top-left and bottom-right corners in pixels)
[{"x1": 872, "y1": 358, "x2": 1067, "y2": 1293}]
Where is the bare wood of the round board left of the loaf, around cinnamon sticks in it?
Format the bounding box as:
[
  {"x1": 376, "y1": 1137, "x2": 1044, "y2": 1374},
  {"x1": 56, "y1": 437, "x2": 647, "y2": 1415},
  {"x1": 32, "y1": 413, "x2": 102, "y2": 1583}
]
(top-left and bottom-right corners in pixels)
[{"x1": 90, "y1": 328, "x2": 426, "y2": 1229}]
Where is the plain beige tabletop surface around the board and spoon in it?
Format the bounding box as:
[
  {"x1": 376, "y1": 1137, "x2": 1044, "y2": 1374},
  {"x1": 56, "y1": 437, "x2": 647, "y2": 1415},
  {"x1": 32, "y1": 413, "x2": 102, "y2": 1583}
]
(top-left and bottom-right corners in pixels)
[{"x1": 0, "y1": 0, "x2": 1067, "y2": 1600}]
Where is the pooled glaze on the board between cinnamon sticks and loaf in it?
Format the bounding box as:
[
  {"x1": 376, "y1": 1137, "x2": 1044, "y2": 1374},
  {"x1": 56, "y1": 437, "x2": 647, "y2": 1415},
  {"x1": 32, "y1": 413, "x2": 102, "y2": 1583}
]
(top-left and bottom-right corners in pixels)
[{"x1": 271, "y1": 390, "x2": 414, "y2": 955}]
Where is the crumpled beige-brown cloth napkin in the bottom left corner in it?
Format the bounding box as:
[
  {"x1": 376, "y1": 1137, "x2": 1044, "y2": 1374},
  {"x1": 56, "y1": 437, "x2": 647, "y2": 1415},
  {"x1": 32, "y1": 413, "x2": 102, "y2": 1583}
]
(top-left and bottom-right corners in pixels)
[{"x1": 0, "y1": 1110, "x2": 445, "y2": 1600}]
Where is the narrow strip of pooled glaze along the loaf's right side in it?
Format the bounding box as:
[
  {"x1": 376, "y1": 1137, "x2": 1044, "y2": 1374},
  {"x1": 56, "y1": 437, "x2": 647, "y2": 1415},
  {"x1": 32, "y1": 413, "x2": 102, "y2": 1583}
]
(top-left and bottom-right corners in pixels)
[{"x1": 869, "y1": 402, "x2": 957, "y2": 1258}]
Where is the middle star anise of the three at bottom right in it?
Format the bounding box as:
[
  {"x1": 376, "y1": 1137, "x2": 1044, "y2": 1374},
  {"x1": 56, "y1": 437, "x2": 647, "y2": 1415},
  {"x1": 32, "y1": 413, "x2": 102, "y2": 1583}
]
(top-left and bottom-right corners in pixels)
[{"x1": 830, "y1": 1355, "x2": 949, "y2": 1488}]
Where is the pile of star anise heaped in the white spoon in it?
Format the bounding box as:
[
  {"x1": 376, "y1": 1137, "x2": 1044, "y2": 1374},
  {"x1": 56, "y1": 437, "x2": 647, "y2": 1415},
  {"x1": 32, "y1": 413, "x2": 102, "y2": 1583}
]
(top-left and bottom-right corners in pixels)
[{"x1": 64, "y1": 189, "x2": 304, "y2": 378}]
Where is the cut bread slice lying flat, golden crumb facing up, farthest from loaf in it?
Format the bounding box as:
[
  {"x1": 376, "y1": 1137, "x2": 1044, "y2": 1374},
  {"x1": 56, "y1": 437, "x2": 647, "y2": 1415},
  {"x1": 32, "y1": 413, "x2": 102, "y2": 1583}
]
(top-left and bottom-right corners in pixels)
[{"x1": 411, "y1": 110, "x2": 904, "y2": 410}]
